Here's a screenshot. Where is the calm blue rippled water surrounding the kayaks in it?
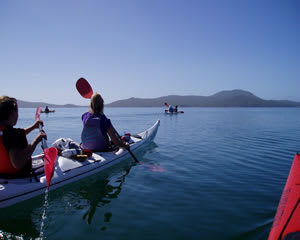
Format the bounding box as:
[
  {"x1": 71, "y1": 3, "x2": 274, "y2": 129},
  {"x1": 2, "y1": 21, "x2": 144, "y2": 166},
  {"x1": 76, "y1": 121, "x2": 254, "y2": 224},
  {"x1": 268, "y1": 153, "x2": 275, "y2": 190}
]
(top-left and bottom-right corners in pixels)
[{"x1": 0, "y1": 108, "x2": 300, "y2": 240}]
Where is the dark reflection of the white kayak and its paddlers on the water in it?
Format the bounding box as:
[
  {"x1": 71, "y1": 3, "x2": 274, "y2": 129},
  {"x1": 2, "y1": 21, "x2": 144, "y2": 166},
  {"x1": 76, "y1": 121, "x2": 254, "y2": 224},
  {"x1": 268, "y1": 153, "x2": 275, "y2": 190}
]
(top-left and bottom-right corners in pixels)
[{"x1": 0, "y1": 165, "x2": 134, "y2": 240}]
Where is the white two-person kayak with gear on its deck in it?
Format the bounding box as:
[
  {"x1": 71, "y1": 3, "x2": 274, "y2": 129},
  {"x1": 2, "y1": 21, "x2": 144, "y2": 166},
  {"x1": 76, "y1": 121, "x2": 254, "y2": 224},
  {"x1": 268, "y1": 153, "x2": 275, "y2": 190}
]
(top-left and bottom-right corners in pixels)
[{"x1": 0, "y1": 120, "x2": 160, "y2": 208}]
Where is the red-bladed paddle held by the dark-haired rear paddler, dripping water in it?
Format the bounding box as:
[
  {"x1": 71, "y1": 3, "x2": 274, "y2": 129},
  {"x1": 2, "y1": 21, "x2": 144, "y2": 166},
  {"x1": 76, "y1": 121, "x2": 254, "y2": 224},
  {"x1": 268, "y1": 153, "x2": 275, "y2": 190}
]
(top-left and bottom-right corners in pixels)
[{"x1": 35, "y1": 107, "x2": 57, "y2": 189}]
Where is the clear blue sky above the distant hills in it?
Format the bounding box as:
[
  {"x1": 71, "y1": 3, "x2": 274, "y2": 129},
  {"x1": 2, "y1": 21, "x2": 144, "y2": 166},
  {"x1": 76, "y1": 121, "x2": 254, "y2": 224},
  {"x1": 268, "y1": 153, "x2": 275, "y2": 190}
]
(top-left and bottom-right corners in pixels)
[{"x1": 0, "y1": 0, "x2": 300, "y2": 105}]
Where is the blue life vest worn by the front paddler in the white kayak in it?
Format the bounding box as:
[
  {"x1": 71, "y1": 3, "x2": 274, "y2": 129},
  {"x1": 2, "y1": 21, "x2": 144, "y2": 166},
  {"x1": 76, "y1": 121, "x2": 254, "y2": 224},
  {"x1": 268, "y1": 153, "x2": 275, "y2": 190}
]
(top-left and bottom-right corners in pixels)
[{"x1": 81, "y1": 115, "x2": 108, "y2": 151}]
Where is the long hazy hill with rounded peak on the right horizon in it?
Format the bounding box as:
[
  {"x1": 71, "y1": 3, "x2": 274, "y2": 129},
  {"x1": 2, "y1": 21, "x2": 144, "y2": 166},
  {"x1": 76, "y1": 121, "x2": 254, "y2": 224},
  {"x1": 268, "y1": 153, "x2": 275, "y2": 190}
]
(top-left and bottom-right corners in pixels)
[{"x1": 106, "y1": 89, "x2": 300, "y2": 107}]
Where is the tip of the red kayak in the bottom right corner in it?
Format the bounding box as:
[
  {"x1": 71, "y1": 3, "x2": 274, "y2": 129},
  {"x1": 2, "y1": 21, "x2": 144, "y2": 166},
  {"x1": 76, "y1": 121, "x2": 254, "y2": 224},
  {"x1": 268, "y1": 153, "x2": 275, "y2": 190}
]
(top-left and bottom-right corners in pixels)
[{"x1": 268, "y1": 153, "x2": 300, "y2": 240}]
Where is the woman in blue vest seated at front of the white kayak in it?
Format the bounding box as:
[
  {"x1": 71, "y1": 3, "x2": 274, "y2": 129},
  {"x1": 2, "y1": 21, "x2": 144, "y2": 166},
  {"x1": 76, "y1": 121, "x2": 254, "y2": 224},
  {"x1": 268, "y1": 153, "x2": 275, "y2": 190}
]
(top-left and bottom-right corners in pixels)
[{"x1": 81, "y1": 93, "x2": 130, "y2": 152}]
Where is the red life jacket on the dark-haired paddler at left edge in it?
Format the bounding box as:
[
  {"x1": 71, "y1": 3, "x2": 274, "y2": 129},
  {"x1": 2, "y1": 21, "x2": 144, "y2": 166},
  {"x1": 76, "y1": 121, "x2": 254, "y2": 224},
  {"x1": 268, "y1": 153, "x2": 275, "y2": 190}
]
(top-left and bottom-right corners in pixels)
[{"x1": 0, "y1": 126, "x2": 17, "y2": 174}]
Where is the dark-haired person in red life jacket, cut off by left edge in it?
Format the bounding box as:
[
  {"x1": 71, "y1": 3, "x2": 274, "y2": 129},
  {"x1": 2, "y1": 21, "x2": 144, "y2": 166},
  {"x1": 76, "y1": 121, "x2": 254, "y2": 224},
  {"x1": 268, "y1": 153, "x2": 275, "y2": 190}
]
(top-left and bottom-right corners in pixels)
[{"x1": 0, "y1": 96, "x2": 47, "y2": 177}]
